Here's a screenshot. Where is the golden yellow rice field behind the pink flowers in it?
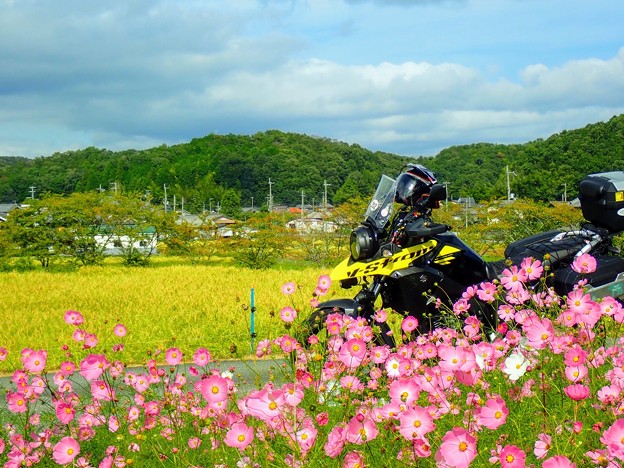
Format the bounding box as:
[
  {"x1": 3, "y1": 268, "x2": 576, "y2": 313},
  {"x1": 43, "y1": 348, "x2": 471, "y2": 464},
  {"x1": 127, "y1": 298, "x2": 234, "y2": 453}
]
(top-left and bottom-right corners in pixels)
[{"x1": 0, "y1": 264, "x2": 334, "y2": 373}]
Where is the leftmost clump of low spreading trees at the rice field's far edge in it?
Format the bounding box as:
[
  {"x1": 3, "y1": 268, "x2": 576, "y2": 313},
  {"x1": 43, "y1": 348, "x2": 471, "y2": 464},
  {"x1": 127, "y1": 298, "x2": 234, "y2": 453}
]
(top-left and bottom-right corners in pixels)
[{"x1": 0, "y1": 193, "x2": 173, "y2": 268}]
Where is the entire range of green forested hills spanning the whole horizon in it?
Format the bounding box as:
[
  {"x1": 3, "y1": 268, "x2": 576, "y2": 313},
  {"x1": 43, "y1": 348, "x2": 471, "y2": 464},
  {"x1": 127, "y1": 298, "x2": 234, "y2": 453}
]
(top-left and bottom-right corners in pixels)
[{"x1": 0, "y1": 114, "x2": 624, "y2": 209}]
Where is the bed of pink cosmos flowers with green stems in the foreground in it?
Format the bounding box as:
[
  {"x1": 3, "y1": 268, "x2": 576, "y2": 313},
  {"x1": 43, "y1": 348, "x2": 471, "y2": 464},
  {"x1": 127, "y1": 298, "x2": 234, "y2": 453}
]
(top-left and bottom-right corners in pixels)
[{"x1": 0, "y1": 255, "x2": 624, "y2": 468}]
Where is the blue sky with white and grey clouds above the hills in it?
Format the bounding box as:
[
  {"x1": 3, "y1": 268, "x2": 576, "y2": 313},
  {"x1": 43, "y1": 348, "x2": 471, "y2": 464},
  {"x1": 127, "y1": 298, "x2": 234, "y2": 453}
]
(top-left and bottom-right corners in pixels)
[{"x1": 0, "y1": 0, "x2": 624, "y2": 157}]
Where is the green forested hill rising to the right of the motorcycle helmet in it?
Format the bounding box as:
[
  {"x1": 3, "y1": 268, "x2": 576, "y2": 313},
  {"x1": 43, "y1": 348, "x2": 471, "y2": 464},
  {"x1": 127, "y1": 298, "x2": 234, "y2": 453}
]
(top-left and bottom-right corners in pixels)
[{"x1": 419, "y1": 114, "x2": 624, "y2": 200}]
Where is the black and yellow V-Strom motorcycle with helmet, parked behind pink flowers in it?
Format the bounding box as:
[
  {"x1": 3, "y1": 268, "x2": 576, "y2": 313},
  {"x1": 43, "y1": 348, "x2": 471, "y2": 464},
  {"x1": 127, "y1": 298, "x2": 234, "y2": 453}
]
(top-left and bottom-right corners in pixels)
[{"x1": 307, "y1": 164, "x2": 624, "y2": 346}]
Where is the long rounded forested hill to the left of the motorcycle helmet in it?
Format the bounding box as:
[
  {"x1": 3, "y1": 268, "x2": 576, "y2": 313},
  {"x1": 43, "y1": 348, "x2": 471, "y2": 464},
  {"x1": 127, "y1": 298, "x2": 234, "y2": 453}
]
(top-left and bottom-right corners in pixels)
[{"x1": 0, "y1": 130, "x2": 408, "y2": 209}]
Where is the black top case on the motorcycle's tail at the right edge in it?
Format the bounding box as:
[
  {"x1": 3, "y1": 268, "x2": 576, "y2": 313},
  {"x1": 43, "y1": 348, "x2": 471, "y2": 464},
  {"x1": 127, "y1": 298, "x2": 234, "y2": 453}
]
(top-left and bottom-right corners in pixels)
[{"x1": 579, "y1": 171, "x2": 624, "y2": 232}]
